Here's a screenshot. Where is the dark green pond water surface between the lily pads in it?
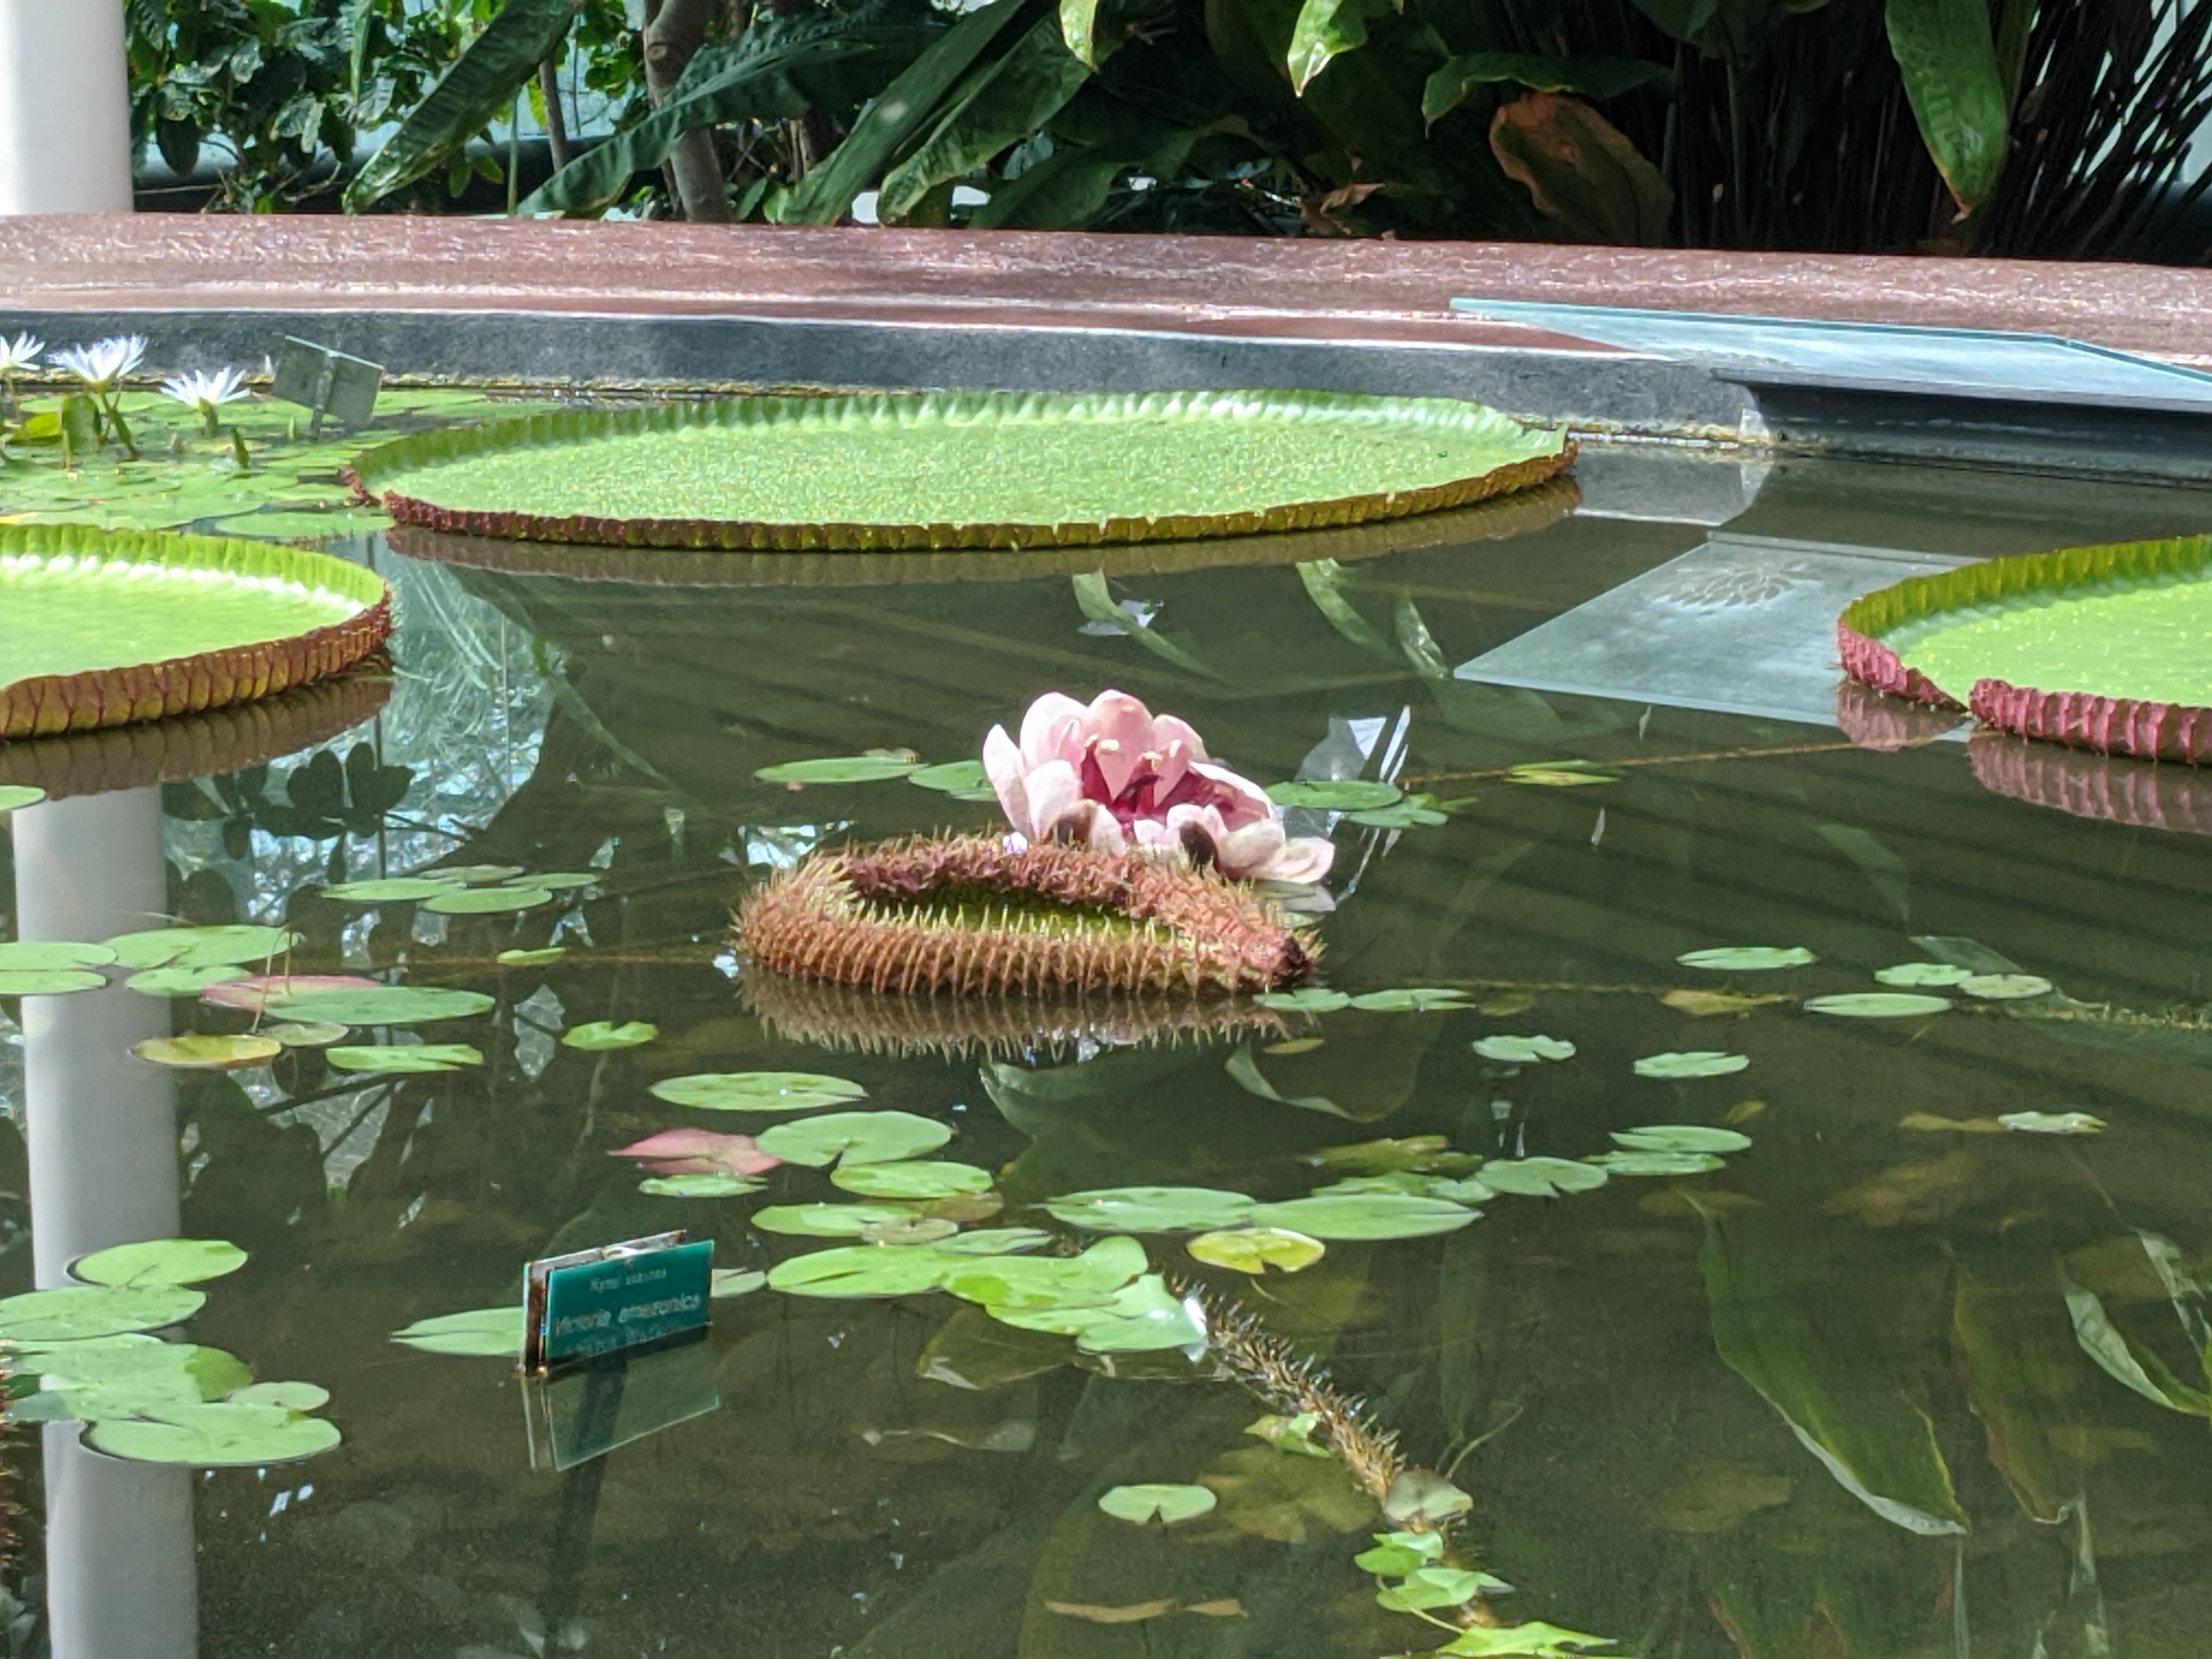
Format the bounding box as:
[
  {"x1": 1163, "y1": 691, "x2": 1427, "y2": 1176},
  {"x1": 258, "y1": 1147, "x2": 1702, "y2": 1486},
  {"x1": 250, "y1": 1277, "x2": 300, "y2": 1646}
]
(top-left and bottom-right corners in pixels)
[{"x1": 0, "y1": 449, "x2": 2212, "y2": 1659}]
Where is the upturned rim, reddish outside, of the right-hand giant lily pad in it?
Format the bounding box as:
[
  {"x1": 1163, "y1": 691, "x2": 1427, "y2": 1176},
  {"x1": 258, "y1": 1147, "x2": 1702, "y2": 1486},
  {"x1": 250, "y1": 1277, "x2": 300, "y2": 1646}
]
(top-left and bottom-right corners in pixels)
[{"x1": 1836, "y1": 536, "x2": 2212, "y2": 766}]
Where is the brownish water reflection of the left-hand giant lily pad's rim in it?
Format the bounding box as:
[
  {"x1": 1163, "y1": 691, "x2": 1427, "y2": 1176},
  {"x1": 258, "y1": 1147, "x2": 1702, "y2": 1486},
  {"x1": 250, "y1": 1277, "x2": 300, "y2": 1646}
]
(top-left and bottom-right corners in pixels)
[{"x1": 0, "y1": 672, "x2": 391, "y2": 801}]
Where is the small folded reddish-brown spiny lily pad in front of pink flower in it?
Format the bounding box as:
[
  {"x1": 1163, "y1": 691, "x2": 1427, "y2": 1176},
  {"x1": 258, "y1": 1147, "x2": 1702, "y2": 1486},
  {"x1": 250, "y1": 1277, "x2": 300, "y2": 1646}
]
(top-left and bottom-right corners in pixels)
[{"x1": 737, "y1": 836, "x2": 1319, "y2": 998}]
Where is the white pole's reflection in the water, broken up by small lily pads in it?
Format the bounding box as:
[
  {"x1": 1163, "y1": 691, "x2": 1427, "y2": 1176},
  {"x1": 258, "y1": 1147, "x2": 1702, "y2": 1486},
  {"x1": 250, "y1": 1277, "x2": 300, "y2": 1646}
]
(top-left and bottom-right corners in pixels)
[{"x1": 11, "y1": 790, "x2": 199, "y2": 1659}]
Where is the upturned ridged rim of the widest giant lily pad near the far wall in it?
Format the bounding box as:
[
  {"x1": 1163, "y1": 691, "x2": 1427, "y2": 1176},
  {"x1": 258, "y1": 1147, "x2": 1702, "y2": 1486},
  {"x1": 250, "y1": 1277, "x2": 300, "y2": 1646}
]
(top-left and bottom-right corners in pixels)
[{"x1": 340, "y1": 391, "x2": 1575, "y2": 551}]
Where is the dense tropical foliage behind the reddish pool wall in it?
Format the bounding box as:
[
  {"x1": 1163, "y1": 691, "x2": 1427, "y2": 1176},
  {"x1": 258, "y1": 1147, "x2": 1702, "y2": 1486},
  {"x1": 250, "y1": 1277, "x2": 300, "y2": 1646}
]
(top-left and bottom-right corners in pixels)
[{"x1": 128, "y1": 0, "x2": 2212, "y2": 261}]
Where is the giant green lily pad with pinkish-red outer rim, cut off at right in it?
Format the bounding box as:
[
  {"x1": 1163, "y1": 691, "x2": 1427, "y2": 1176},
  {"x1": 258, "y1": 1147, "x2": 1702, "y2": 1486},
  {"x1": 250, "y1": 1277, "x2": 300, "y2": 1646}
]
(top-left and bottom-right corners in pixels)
[{"x1": 1836, "y1": 536, "x2": 2212, "y2": 763}]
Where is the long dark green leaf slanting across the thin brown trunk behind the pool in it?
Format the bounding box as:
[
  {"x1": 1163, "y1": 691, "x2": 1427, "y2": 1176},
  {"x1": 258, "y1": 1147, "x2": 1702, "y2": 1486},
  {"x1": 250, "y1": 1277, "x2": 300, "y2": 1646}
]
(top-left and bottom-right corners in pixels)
[{"x1": 520, "y1": 7, "x2": 944, "y2": 213}]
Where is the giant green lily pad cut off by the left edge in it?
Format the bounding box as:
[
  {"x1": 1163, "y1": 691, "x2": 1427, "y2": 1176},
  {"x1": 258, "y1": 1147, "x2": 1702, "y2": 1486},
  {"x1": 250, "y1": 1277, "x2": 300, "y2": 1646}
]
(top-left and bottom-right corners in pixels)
[{"x1": 0, "y1": 524, "x2": 391, "y2": 739}]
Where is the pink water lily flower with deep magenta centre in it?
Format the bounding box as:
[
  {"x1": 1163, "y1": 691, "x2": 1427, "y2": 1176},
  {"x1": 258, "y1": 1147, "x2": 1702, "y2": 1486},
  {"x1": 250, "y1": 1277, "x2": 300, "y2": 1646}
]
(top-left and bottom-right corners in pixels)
[{"x1": 982, "y1": 690, "x2": 1336, "y2": 883}]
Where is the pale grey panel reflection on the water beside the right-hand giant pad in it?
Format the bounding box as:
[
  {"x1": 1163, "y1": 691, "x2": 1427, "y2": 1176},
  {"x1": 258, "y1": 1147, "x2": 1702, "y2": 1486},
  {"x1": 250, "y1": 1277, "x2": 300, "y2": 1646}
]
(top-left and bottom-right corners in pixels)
[{"x1": 1454, "y1": 531, "x2": 1967, "y2": 726}]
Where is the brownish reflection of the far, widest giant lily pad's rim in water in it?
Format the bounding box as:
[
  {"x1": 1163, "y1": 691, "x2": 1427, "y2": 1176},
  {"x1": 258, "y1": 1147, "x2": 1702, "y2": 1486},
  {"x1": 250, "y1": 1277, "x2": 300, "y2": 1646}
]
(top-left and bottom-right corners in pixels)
[{"x1": 387, "y1": 478, "x2": 1581, "y2": 589}]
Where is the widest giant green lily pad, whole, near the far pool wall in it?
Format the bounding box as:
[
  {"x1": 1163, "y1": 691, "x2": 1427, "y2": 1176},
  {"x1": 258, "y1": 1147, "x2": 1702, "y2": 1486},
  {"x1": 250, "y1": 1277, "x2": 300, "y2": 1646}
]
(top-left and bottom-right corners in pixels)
[{"x1": 354, "y1": 391, "x2": 1575, "y2": 549}]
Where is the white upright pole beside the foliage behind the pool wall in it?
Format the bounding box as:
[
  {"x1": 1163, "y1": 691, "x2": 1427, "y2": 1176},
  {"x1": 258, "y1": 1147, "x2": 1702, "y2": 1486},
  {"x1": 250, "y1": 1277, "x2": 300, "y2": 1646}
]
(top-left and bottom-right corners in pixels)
[{"x1": 0, "y1": 0, "x2": 131, "y2": 215}]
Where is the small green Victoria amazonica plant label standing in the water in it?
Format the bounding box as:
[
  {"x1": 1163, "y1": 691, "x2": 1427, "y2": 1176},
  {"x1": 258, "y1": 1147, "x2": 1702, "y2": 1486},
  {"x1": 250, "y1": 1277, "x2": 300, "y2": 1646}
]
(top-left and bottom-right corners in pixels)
[{"x1": 522, "y1": 1230, "x2": 715, "y2": 1372}]
